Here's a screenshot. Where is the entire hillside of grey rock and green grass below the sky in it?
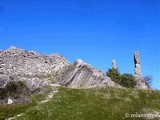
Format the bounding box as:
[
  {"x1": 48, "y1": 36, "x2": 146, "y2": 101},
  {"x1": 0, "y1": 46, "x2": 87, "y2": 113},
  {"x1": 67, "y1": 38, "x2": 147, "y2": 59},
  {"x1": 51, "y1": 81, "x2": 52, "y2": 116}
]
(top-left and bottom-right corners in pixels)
[{"x1": 0, "y1": 47, "x2": 160, "y2": 120}]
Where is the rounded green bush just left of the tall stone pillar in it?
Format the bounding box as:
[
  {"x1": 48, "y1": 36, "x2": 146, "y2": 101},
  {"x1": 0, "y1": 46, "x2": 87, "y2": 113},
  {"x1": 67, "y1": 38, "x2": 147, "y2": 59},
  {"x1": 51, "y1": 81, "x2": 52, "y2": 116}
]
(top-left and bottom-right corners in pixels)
[{"x1": 120, "y1": 73, "x2": 136, "y2": 88}]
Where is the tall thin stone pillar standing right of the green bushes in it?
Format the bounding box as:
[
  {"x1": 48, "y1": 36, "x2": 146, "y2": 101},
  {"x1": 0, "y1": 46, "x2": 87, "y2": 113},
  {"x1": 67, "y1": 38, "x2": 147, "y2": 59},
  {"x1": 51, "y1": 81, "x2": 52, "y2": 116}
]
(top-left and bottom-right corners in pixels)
[{"x1": 134, "y1": 51, "x2": 149, "y2": 89}]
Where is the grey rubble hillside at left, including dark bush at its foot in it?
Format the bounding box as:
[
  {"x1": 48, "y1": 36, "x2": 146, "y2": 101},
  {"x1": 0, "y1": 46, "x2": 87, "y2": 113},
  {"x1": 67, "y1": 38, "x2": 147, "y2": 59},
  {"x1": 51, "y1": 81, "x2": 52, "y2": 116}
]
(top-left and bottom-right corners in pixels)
[{"x1": 0, "y1": 47, "x2": 70, "y2": 104}]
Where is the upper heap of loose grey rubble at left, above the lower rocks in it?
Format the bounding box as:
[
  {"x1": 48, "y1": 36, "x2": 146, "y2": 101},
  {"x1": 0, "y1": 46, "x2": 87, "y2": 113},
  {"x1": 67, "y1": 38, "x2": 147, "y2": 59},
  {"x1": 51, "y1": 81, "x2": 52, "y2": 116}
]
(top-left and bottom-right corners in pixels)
[{"x1": 0, "y1": 47, "x2": 69, "y2": 77}]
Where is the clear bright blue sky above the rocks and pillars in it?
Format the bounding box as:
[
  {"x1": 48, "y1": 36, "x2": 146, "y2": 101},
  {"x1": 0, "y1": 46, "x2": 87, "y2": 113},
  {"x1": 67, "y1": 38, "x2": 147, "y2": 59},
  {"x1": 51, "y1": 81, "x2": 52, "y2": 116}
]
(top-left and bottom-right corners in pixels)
[{"x1": 0, "y1": 0, "x2": 160, "y2": 89}]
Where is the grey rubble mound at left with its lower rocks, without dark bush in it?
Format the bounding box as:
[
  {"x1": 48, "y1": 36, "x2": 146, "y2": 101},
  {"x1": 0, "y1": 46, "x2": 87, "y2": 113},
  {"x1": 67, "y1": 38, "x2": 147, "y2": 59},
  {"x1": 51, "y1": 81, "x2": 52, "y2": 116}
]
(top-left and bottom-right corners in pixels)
[{"x1": 0, "y1": 47, "x2": 70, "y2": 103}]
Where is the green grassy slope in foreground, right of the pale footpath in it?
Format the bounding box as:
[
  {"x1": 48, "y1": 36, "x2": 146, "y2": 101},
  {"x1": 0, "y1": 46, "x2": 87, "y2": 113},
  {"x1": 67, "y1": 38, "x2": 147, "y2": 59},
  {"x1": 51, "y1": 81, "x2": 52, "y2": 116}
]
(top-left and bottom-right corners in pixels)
[{"x1": 0, "y1": 87, "x2": 160, "y2": 120}]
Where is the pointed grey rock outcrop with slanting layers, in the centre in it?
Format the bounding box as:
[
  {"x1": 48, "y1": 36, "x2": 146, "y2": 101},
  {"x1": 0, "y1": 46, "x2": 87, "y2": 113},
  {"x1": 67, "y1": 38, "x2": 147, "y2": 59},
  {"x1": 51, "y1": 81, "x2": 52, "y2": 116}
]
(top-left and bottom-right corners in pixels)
[{"x1": 56, "y1": 59, "x2": 116, "y2": 88}]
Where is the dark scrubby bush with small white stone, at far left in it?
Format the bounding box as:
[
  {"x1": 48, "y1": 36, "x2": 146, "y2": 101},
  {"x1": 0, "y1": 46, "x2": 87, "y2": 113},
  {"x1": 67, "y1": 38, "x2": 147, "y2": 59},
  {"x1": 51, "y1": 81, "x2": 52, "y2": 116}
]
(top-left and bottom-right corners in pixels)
[{"x1": 0, "y1": 81, "x2": 33, "y2": 104}]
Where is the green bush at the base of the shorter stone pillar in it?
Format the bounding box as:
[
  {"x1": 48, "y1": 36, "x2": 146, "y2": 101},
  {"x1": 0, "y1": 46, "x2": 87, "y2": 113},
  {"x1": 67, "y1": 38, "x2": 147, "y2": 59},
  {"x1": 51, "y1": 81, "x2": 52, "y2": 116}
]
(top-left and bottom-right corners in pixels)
[{"x1": 106, "y1": 68, "x2": 121, "y2": 84}]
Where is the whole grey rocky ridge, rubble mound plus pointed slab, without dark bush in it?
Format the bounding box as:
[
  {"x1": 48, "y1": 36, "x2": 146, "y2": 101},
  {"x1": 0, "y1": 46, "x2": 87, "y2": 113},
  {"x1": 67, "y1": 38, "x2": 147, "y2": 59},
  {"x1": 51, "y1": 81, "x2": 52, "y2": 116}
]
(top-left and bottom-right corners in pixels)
[{"x1": 0, "y1": 47, "x2": 118, "y2": 103}]
